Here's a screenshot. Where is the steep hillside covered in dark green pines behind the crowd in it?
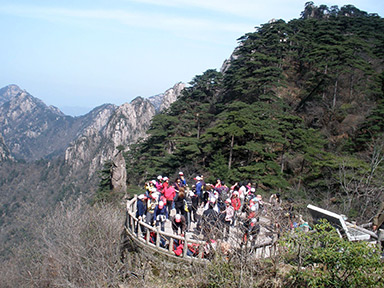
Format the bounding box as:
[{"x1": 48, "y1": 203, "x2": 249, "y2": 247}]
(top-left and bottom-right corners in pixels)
[{"x1": 126, "y1": 2, "x2": 384, "y2": 219}]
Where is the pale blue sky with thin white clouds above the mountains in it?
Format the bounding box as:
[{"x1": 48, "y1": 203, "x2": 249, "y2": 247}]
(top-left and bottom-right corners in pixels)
[{"x1": 0, "y1": 0, "x2": 384, "y2": 114}]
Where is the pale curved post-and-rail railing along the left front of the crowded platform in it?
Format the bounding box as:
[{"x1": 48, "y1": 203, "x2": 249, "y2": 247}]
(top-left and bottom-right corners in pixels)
[{"x1": 125, "y1": 195, "x2": 206, "y2": 261}]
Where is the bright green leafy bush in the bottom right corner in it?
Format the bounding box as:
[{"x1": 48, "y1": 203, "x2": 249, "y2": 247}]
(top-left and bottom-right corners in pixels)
[{"x1": 281, "y1": 222, "x2": 384, "y2": 288}]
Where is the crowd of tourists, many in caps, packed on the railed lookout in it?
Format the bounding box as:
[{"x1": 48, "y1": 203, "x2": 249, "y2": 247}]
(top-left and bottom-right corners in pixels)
[{"x1": 136, "y1": 172, "x2": 308, "y2": 258}]
